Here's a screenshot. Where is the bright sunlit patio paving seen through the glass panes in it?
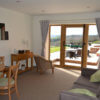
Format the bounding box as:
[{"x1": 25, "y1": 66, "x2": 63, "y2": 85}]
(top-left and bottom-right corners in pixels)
[{"x1": 50, "y1": 44, "x2": 100, "y2": 68}]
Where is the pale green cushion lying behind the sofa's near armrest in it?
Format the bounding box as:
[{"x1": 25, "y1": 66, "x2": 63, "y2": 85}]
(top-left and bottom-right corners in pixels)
[{"x1": 69, "y1": 88, "x2": 96, "y2": 97}]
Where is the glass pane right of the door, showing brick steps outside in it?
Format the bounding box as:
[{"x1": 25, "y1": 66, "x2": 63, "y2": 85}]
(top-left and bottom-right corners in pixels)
[{"x1": 87, "y1": 25, "x2": 100, "y2": 69}]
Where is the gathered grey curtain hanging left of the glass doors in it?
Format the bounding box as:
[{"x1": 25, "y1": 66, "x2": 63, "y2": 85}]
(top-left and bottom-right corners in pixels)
[{"x1": 40, "y1": 20, "x2": 49, "y2": 56}]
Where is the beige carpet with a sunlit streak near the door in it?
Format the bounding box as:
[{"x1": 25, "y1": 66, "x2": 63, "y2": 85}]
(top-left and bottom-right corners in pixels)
[{"x1": 0, "y1": 68, "x2": 80, "y2": 100}]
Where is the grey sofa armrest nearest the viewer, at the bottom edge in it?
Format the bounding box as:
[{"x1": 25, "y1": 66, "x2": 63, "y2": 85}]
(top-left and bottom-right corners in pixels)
[{"x1": 59, "y1": 91, "x2": 98, "y2": 100}]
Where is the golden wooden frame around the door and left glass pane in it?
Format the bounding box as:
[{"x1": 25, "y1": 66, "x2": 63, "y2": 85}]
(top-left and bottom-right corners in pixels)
[{"x1": 49, "y1": 24, "x2": 90, "y2": 69}]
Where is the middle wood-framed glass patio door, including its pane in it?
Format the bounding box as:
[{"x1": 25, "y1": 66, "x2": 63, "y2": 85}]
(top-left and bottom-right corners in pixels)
[{"x1": 61, "y1": 25, "x2": 88, "y2": 69}]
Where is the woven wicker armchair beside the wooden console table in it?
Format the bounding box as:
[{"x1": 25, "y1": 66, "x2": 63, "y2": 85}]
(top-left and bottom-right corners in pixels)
[{"x1": 34, "y1": 54, "x2": 54, "y2": 74}]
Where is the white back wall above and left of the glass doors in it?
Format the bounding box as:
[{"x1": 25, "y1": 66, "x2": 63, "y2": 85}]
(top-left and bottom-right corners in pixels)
[{"x1": 33, "y1": 12, "x2": 100, "y2": 54}]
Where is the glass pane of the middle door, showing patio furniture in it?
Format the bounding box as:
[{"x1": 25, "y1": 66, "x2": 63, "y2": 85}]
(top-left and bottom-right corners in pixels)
[{"x1": 65, "y1": 27, "x2": 83, "y2": 67}]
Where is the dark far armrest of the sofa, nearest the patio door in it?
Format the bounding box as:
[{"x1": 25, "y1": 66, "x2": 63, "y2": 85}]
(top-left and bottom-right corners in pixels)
[{"x1": 81, "y1": 68, "x2": 97, "y2": 77}]
